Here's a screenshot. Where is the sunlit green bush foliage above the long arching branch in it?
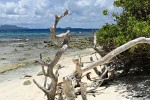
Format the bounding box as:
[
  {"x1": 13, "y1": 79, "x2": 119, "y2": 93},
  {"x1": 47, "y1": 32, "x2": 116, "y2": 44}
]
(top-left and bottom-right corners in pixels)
[{"x1": 97, "y1": 0, "x2": 150, "y2": 51}]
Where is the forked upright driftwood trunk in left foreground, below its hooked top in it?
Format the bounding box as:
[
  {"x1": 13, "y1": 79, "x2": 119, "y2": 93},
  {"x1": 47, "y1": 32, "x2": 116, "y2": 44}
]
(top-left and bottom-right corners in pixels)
[{"x1": 33, "y1": 44, "x2": 68, "y2": 100}]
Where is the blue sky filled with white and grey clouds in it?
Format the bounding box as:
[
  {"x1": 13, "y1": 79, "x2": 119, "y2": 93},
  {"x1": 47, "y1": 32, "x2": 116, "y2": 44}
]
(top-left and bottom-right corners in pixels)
[{"x1": 0, "y1": 0, "x2": 121, "y2": 28}]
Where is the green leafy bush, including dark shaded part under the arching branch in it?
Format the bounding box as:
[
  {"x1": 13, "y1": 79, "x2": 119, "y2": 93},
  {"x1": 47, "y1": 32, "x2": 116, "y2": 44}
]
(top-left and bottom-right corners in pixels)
[{"x1": 96, "y1": 0, "x2": 150, "y2": 72}]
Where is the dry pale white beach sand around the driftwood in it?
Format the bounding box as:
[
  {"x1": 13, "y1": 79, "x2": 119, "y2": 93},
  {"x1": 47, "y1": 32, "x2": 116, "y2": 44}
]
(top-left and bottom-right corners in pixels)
[{"x1": 0, "y1": 49, "x2": 127, "y2": 100}]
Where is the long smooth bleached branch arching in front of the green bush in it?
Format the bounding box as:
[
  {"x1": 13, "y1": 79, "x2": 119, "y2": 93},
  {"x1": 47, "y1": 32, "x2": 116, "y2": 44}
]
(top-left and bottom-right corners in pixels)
[{"x1": 82, "y1": 37, "x2": 150, "y2": 73}]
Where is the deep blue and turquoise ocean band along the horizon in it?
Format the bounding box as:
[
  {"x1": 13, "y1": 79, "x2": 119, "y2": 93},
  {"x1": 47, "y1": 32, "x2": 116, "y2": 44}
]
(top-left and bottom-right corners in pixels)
[{"x1": 0, "y1": 28, "x2": 97, "y2": 42}]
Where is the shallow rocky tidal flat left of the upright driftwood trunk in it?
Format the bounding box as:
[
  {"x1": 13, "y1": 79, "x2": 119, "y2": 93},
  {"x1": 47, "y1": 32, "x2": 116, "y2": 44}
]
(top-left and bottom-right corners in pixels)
[{"x1": 0, "y1": 41, "x2": 75, "y2": 73}]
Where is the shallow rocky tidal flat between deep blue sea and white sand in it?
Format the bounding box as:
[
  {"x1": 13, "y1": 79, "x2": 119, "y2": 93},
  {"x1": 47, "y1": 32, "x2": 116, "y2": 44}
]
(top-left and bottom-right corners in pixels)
[{"x1": 0, "y1": 37, "x2": 94, "y2": 73}]
